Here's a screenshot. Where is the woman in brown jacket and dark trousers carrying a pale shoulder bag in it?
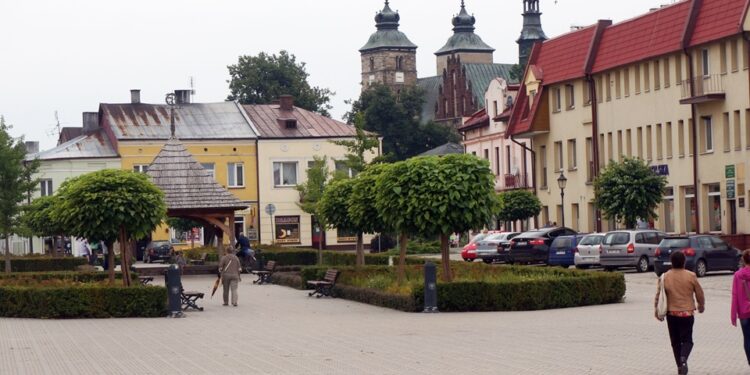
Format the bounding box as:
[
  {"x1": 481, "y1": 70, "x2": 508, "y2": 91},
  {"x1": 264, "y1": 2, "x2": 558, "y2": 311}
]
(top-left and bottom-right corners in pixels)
[{"x1": 654, "y1": 251, "x2": 706, "y2": 375}]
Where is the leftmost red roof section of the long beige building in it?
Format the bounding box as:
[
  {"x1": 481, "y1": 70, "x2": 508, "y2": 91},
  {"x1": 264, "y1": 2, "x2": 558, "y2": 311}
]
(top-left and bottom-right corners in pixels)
[{"x1": 536, "y1": 25, "x2": 596, "y2": 85}]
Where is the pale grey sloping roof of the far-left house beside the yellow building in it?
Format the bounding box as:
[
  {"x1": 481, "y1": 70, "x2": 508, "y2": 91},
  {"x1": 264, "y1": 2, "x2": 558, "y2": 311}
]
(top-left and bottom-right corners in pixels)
[{"x1": 26, "y1": 130, "x2": 119, "y2": 160}]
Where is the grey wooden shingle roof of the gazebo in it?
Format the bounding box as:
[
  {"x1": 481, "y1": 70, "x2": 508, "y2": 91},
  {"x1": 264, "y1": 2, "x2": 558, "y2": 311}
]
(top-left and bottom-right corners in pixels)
[{"x1": 147, "y1": 138, "x2": 249, "y2": 210}]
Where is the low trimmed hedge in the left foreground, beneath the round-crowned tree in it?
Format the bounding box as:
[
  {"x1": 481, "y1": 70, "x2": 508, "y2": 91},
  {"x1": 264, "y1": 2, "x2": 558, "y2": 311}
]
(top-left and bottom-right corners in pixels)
[{"x1": 0, "y1": 284, "x2": 167, "y2": 319}]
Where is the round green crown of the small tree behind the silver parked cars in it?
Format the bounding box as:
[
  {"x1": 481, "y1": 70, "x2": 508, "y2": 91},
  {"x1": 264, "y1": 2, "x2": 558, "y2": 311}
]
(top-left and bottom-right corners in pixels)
[{"x1": 594, "y1": 157, "x2": 667, "y2": 228}]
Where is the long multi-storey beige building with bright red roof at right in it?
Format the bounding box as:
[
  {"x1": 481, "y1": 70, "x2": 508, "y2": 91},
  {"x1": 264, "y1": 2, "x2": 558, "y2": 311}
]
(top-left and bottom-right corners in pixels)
[{"x1": 509, "y1": 0, "x2": 750, "y2": 238}]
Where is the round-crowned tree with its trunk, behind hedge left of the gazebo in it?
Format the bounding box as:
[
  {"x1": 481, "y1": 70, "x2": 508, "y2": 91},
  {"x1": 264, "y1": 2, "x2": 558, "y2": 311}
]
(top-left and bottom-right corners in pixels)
[{"x1": 52, "y1": 169, "x2": 167, "y2": 283}]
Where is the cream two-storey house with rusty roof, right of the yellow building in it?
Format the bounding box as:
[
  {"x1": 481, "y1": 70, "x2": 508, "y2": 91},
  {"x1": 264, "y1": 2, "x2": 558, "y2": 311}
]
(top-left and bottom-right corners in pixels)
[{"x1": 243, "y1": 96, "x2": 377, "y2": 249}]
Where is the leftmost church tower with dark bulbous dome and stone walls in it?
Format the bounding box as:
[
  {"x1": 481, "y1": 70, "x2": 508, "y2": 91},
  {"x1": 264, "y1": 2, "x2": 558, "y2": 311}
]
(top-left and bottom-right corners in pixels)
[{"x1": 359, "y1": 0, "x2": 417, "y2": 91}]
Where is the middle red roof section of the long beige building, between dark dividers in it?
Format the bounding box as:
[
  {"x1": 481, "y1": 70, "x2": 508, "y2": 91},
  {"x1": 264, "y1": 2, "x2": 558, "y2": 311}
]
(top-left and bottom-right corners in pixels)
[{"x1": 592, "y1": 0, "x2": 692, "y2": 73}]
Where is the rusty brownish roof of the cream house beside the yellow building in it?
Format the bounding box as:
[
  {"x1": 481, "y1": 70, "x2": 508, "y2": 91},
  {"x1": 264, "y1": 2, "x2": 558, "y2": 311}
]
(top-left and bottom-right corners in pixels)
[{"x1": 242, "y1": 104, "x2": 356, "y2": 138}]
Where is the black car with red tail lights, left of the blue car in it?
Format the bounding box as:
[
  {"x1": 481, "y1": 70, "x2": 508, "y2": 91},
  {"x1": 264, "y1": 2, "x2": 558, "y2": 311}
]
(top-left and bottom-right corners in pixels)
[{"x1": 508, "y1": 227, "x2": 577, "y2": 264}]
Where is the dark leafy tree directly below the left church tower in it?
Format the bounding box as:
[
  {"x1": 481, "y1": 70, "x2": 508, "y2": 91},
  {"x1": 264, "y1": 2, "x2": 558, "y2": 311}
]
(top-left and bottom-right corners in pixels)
[{"x1": 346, "y1": 85, "x2": 460, "y2": 161}]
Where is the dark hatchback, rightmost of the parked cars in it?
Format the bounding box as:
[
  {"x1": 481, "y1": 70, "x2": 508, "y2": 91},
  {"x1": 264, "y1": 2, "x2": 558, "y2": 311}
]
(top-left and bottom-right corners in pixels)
[{"x1": 654, "y1": 235, "x2": 743, "y2": 277}]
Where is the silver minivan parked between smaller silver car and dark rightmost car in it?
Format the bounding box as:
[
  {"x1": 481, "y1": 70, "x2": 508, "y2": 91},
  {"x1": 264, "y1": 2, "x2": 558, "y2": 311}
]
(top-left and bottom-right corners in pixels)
[{"x1": 599, "y1": 229, "x2": 666, "y2": 272}]
